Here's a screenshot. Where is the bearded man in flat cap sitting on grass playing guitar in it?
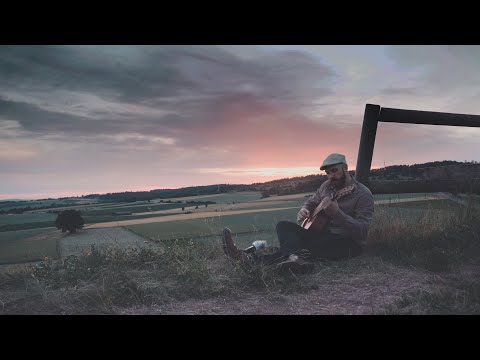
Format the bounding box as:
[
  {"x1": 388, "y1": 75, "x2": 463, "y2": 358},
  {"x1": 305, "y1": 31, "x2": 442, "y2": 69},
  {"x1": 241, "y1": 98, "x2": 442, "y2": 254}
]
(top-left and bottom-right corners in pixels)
[{"x1": 222, "y1": 153, "x2": 374, "y2": 273}]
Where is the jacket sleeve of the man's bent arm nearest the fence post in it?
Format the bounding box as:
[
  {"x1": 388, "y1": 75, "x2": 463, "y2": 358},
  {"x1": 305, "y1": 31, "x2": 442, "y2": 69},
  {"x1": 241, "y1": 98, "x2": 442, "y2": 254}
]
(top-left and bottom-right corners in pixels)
[{"x1": 333, "y1": 193, "x2": 374, "y2": 245}]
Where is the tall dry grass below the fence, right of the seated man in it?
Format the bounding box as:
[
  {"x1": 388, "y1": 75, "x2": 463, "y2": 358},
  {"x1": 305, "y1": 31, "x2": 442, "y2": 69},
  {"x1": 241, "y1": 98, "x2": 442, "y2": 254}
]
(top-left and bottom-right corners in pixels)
[{"x1": 369, "y1": 198, "x2": 480, "y2": 271}]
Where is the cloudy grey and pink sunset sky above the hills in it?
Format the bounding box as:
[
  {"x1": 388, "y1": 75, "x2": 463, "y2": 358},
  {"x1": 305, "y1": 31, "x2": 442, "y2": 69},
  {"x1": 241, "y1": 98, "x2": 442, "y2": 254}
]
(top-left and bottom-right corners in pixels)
[{"x1": 0, "y1": 45, "x2": 480, "y2": 199}]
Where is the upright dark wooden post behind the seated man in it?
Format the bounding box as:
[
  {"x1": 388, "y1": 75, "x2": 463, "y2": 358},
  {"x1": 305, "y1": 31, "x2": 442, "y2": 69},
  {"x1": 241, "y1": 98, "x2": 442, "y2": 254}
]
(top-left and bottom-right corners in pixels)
[{"x1": 355, "y1": 104, "x2": 380, "y2": 186}]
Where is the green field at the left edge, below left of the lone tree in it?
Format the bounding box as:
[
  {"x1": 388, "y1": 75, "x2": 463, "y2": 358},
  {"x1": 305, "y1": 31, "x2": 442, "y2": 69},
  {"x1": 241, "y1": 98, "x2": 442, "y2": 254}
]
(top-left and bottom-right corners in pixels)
[{"x1": 0, "y1": 228, "x2": 58, "y2": 264}]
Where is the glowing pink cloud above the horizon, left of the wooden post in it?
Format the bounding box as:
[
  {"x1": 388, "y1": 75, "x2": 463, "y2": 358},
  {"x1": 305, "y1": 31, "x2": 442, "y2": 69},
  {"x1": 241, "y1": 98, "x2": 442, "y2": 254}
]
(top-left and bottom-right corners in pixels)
[{"x1": 183, "y1": 100, "x2": 360, "y2": 168}]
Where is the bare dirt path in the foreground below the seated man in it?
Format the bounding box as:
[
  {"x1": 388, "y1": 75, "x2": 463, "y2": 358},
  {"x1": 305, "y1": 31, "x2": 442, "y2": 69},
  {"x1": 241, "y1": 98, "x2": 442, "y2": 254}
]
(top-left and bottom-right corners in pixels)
[{"x1": 117, "y1": 257, "x2": 479, "y2": 315}]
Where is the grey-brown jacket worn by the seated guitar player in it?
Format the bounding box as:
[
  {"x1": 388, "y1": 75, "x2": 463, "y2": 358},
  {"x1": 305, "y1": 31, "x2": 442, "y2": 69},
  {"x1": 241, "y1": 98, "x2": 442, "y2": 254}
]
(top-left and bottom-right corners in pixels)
[{"x1": 297, "y1": 176, "x2": 374, "y2": 246}]
